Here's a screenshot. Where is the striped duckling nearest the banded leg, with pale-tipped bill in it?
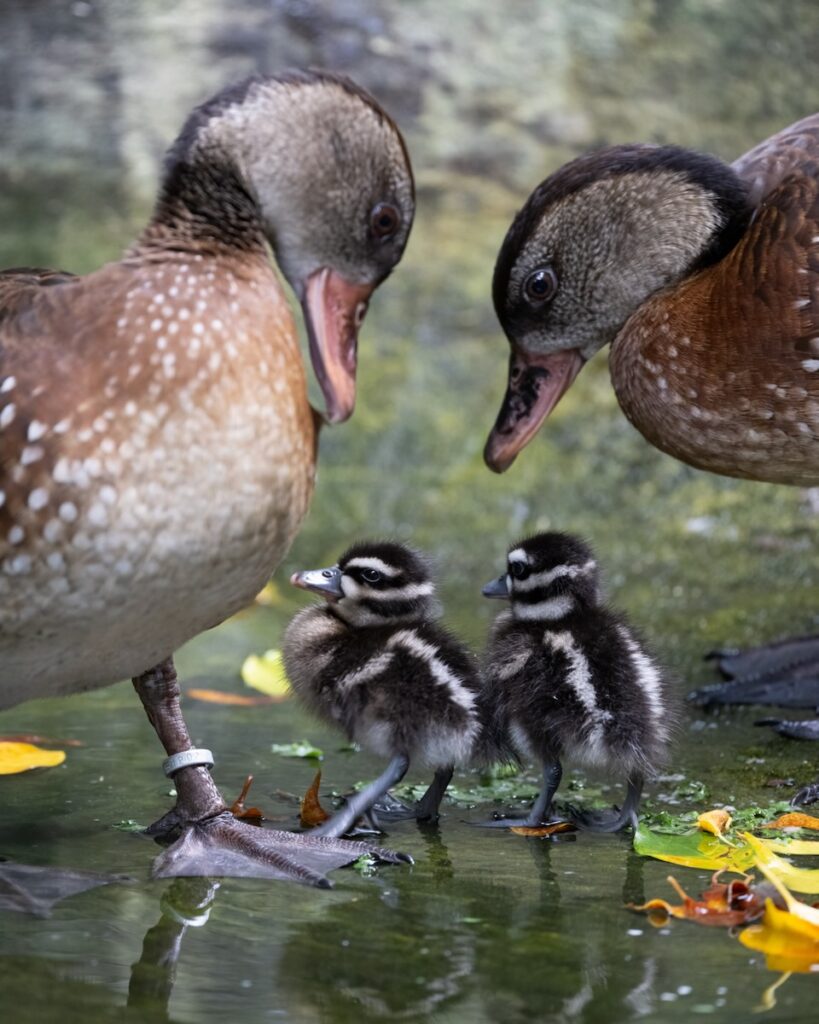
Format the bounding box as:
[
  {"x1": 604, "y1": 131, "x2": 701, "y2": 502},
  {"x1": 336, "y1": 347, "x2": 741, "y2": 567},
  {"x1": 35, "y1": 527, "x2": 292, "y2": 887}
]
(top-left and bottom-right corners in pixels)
[{"x1": 283, "y1": 541, "x2": 480, "y2": 837}]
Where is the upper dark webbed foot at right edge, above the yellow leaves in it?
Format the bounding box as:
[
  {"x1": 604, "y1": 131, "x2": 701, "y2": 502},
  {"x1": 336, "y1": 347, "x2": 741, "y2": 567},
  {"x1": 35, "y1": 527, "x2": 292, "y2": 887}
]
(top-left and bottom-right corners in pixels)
[{"x1": 688, "y1": 637, "x2": 819, "y2": 708}]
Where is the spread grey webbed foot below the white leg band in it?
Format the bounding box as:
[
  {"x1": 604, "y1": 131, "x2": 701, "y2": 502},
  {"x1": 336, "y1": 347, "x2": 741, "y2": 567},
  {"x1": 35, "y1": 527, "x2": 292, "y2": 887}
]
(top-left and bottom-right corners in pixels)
[{"x1": 152, "y1": 811, "x2": 412, "y2": 889}]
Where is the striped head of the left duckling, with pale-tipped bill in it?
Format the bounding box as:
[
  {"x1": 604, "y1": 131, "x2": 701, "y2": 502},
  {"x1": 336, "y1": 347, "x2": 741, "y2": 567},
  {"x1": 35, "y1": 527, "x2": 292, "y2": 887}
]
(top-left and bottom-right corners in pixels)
[{"x1": 290, "y1": 541, "x2": 439, "y2": 628}]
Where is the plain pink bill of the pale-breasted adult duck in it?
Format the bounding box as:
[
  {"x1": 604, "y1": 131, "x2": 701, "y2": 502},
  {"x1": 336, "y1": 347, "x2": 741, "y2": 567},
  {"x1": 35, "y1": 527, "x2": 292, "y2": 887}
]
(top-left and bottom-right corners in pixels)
[{"x1": 302, "y1": 267, "x2": 375, "y2": 423}]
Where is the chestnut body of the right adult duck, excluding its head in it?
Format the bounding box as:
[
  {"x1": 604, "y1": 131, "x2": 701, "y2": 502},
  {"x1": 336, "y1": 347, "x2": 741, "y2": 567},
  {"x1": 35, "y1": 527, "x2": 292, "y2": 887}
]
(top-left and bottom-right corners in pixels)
[{"x1": 611, "y1": 122, "x2": 819, "y2": 484}]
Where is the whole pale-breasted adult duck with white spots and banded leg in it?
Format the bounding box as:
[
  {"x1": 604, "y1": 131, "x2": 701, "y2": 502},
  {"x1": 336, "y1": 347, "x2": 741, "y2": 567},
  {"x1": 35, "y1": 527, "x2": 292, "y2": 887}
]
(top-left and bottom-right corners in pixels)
[{"x1": 0, "y1": 71, "x2": 415, "y2": 884}]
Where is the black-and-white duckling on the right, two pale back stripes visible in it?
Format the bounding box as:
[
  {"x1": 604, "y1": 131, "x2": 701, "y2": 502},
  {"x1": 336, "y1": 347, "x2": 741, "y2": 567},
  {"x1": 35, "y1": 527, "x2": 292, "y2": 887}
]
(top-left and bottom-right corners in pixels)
[{"x1": 483, "y1": 532, "x2": 669, "y2": 831}]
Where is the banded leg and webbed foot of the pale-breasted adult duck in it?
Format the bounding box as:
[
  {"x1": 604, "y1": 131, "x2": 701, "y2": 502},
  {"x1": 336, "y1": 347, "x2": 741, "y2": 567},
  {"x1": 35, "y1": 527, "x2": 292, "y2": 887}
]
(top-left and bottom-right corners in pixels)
[{"x1": 133, "y1": 658, "x2": 407, "y2": 888}]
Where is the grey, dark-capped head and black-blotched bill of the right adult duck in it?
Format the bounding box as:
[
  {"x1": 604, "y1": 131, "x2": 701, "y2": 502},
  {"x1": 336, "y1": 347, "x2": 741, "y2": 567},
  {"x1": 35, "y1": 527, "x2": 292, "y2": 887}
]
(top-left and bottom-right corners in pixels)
[{"x1": 484, "y1": 145, "x2": 750, "y2": 473}]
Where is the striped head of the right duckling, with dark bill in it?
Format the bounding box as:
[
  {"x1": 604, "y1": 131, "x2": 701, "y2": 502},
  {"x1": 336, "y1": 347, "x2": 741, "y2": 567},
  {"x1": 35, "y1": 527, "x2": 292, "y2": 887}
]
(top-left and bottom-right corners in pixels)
[{"x1": 482, "y1": 532, "x2": 600, "y2": 622}]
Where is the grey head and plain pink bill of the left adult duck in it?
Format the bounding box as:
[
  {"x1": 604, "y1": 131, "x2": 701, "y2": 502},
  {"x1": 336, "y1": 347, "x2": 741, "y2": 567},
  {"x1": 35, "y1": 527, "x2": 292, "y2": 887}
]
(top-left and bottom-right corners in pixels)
[{"x1": 159, "y1": 71, "x2": 415, "y2": 423}]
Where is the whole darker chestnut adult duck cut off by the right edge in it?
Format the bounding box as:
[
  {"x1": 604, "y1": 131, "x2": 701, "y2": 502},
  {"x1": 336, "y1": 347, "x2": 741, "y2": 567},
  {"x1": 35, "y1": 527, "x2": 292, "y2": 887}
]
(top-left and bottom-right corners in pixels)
[{"x1": 485, "y1": 115, "x2": 819, "y2": 801}]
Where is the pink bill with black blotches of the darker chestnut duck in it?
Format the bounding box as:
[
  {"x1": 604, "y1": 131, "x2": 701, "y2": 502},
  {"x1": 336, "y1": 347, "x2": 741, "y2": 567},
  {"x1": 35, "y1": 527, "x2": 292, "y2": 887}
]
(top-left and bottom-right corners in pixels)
[{"x1": 483, "y1": 345, "x2": 586, "y2": 473}]
